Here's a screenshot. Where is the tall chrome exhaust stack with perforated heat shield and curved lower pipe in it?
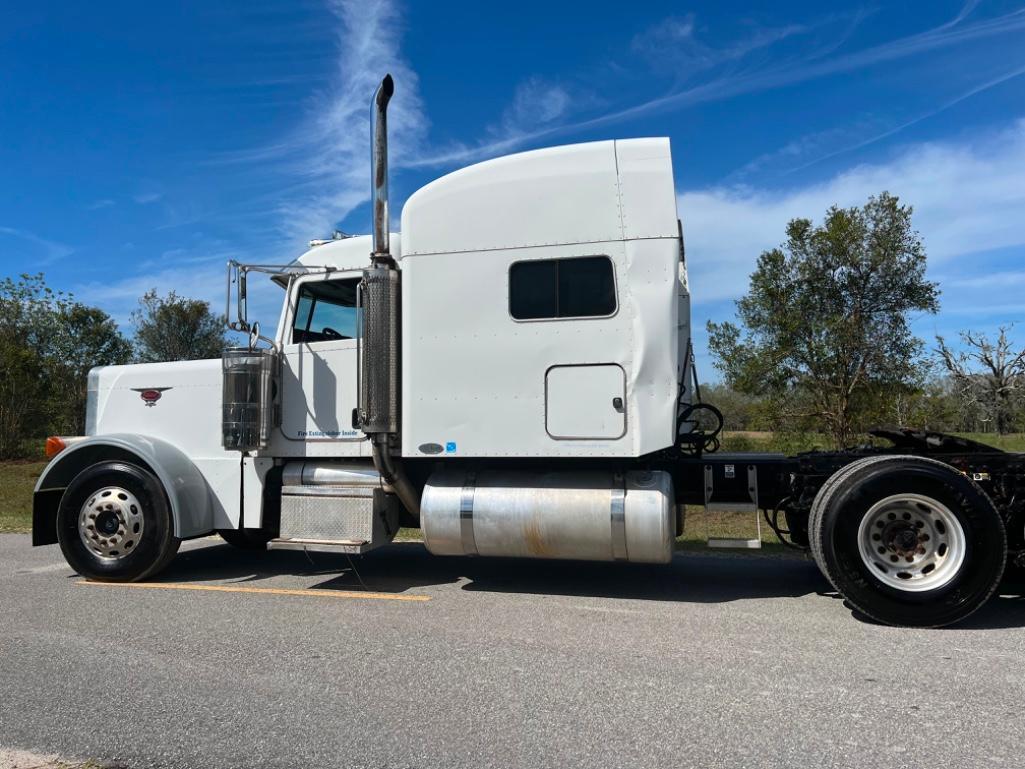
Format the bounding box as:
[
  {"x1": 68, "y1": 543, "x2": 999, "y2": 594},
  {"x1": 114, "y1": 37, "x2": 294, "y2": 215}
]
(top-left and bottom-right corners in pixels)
[{"x1": 360, "y1": 75, "x2": 420, "y2": 518}]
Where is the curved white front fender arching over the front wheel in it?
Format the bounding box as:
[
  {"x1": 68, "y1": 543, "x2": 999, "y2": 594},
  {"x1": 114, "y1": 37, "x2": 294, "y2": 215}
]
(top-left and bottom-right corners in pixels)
[{"x1": 32, "y1": 433, "x2": 213, "y2": 544}]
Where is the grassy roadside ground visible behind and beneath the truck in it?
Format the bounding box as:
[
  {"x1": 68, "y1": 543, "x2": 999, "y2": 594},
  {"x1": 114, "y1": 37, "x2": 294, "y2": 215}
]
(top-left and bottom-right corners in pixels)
[{"x1": 0, "y1": 432, "x2": 1025, "y2": 551}]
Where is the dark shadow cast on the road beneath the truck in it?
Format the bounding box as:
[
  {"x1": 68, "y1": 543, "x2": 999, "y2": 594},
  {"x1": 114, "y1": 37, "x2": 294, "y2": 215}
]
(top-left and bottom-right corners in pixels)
[{"x1": 161, "y1": 542, "x2": 1025, "y2": 630}]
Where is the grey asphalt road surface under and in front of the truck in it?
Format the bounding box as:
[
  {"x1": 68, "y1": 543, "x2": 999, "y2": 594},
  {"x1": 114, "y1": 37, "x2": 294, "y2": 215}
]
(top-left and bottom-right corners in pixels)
[{"x1": 0, "y1": 535, "x2": 1025, "y2": 769}]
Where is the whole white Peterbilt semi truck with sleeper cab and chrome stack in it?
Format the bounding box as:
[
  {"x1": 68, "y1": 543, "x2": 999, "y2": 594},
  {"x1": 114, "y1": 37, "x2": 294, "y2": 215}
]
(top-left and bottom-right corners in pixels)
[{"x1": 33, "y1": 77, "x2": 1025, "y2": 625}]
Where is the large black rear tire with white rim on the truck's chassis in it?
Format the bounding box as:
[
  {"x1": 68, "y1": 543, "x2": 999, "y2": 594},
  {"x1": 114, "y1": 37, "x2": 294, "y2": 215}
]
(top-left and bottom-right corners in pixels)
[{"x1": 810, "y1": 456, "x2": 1007, "y2": 626}]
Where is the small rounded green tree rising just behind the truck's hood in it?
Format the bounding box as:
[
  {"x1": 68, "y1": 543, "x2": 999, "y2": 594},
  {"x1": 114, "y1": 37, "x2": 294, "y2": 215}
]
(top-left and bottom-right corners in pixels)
[{"x1": 132, "y1": 289, "x2": 228, "y2": 362}]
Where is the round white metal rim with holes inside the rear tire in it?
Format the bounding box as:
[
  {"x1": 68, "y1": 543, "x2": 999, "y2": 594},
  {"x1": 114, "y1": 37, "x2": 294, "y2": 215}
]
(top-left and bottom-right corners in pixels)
[{"x1": 858, "y1": 494, "x2": 966, "y2": 593}]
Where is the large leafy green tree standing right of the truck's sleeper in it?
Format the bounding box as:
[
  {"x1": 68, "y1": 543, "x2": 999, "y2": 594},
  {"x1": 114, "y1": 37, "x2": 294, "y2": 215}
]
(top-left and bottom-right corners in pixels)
[{"x1": 708, "y1": 193, "x2": 939, "y2": 446}]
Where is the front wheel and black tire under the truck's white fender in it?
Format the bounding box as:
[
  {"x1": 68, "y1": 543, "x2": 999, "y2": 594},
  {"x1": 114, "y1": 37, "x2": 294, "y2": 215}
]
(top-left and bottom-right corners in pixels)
[{"x1": 57, "y1": 461, "x2": 181, "y2": 582}]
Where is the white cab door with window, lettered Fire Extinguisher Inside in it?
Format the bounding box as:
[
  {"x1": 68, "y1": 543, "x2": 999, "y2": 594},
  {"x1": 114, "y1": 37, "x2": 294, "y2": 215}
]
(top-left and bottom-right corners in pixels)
[{"x1": 281, "y1": 273, "x2": 364, "y2": 444}]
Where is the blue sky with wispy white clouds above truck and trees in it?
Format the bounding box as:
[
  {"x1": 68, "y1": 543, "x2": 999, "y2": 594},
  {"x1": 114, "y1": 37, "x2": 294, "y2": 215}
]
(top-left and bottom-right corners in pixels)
[{"x1": 0, "y1": 0, "x2": 1025, "y2": 378}]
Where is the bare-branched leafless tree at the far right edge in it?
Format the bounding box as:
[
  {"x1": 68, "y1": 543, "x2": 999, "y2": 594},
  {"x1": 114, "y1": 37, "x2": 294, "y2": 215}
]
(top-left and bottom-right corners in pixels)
[{"x1": 936, "y1": 326, "x2": 1025, "y2": 435}]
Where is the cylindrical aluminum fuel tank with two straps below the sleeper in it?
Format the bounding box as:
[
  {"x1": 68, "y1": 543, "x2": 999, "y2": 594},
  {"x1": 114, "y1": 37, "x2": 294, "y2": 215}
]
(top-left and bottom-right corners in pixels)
[{"x1": 420, "y1": 470, "x2": 675, "y2": 563}]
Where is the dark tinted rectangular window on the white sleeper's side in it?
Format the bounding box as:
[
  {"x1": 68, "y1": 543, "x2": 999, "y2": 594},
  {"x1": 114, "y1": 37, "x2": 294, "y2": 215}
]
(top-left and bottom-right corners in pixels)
[{"x1": 509, "y1": 256, "x2": 616, "y2": 320}]
